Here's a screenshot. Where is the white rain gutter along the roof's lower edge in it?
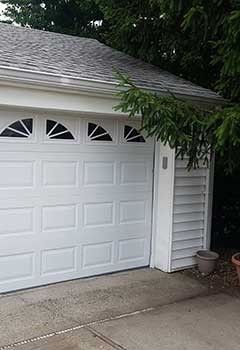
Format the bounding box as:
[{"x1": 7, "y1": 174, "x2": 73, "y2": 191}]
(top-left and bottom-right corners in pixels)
[{"x1": 0, "y1": 66, "x2": 226, "y2": 107}]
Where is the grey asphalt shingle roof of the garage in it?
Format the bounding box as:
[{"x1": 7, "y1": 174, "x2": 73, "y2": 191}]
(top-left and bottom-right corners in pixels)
[{"x1": 0, "y1": 23, "x2": 221, "y2": 100}]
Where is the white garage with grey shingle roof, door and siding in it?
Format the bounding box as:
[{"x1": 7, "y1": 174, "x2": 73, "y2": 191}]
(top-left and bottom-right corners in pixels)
[{"x1": 0, "y1": 23, "x2": 222, "y2": 294}]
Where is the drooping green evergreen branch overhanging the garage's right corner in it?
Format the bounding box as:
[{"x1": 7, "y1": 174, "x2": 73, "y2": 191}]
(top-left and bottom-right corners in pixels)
[{"x1": 115, "y1": 72, "x2": 240, "y2": 172}]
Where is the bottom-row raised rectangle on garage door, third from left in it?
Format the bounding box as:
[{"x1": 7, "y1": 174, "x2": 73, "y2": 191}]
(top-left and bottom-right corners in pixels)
[{"x1": 82, "y1": 242, "x2": 113, "y2": 268}]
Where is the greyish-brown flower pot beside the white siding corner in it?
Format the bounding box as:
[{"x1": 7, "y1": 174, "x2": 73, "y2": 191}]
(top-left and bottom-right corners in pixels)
[{"x1": 196, "y1": 250, "x2": 219, "y2": 275}]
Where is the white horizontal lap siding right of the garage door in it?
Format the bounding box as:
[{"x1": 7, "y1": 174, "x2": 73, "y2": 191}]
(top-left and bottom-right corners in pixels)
[{"x1": 171, "y1": 159, "x2": 208, "y2": 271}]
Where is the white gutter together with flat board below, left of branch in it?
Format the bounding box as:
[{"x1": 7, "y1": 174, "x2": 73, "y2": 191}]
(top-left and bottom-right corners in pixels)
[{"x1": 0, "y1": 67, "x2": 126, "y2": 116}]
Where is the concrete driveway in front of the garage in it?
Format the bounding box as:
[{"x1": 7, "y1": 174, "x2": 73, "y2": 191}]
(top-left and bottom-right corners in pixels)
[{"x1": 0, "y1": 269, "x2": 240, "y2": 350}]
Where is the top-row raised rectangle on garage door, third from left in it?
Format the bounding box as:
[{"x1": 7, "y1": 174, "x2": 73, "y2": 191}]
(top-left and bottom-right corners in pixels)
[{"x1": 83, "y1": 161, "x2": 115, "y2": 185}]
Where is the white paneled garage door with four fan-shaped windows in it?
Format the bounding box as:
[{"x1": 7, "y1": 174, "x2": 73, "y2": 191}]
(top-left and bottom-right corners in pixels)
[{"x1": 0, "y1": 112, "x2": 153, "y2": 292}]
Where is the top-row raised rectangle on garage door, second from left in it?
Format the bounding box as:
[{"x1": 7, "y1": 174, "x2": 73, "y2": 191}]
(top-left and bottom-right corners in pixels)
[{"x1": 42, "y1": 161, "x2": 77, "y2": 187}]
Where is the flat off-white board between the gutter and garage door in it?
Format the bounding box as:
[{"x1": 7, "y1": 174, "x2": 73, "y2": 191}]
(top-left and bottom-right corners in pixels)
[{"x1": 0, "y1": 83, "x2": 124, "y2": 116}]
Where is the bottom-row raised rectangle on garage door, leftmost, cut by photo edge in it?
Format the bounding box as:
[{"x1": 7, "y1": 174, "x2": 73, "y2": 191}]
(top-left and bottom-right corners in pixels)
[{"x1": 0, "y1": 253, "x2": 34, "y2": 282}]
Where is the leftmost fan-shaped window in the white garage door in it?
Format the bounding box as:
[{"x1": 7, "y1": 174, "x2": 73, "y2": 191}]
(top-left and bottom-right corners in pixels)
[{"x1": 0, "y1": 119, "x2": 33, "y2": 138}]
